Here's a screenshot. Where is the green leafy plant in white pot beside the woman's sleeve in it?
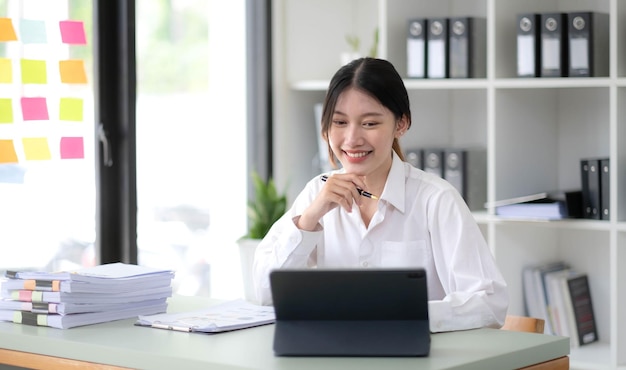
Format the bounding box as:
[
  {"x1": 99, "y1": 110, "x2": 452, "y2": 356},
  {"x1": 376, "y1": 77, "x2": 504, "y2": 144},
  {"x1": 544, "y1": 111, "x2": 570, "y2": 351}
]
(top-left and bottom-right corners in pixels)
[{"x1": 238, "y1": 172, "x2": 287, "y2": 303}]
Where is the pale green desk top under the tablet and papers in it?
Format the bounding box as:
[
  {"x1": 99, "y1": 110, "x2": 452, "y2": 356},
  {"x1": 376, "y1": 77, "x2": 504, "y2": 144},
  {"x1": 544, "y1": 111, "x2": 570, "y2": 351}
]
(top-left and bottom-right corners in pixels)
[{"x1": 0, "y1": 296, "x2": 569, "y2": 370}]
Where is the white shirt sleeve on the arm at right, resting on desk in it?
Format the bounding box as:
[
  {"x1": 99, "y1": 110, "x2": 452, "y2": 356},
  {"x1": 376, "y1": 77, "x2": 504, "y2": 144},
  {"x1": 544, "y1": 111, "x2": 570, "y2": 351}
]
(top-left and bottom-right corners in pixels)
[{"x1": 428, "y1": 186, "x2": 509, "y2": 332}]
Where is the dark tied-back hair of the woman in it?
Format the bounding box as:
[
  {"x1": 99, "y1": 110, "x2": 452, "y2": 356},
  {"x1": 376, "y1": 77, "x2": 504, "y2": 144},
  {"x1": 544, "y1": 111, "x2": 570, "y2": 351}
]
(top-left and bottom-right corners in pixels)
[{"x1": 321, "y1": 57, "x2": 411, "y2": 167}]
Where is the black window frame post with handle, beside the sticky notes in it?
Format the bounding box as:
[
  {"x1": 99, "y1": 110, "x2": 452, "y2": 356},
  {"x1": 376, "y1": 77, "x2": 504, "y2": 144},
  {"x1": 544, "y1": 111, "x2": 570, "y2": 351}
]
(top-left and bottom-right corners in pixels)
[{"x1": 94, "y1": 0, "x2": 137, "y2": 263}]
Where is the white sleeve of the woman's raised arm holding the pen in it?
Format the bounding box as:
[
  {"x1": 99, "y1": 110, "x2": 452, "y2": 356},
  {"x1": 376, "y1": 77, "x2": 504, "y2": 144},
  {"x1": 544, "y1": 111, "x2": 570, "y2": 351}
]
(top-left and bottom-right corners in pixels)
[{"x1": 253, "y1": 183, "x2": 323, "y2": 305}]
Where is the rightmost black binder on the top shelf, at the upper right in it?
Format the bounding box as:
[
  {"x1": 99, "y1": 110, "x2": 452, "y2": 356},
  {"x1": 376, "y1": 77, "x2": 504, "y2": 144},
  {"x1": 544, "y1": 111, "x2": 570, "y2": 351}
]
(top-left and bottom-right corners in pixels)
[{"x1": 567, "y1": 12, "x2": 609, "y2": 77}]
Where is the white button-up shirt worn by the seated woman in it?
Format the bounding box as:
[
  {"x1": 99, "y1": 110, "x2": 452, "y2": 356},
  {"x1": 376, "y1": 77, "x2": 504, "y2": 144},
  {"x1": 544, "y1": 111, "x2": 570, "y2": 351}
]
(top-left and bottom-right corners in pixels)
[{"x1": 254, "y1": 153, "x2": 508, "y2": 332}]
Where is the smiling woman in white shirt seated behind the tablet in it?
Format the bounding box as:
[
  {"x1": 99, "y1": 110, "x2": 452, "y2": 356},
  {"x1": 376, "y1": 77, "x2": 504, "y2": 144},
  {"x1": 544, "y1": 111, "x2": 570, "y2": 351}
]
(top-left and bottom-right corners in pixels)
[{"x1": 254, "y1": 58, "x2": 508, "y2": 332}]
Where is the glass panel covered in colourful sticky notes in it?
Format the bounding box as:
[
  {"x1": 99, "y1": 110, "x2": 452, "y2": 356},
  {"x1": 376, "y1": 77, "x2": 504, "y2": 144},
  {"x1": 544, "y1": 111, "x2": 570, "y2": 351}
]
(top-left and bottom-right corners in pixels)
[{"x1": 0, "y1": 0, "x2": 95, "y2": 270}]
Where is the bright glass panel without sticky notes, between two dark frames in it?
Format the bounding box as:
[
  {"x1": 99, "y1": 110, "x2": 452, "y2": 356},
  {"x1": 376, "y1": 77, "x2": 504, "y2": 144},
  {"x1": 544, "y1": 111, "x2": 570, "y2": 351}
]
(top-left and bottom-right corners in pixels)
[{"x1": 136, "y1": 0, "x2": 247, "y2": 298}]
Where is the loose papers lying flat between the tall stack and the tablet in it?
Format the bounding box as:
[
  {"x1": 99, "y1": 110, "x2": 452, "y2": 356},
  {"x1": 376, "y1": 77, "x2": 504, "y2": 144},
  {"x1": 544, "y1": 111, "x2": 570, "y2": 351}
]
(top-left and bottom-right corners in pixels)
[{"x1": 136, "y1": 299, "x2": 276, "y2": 333}]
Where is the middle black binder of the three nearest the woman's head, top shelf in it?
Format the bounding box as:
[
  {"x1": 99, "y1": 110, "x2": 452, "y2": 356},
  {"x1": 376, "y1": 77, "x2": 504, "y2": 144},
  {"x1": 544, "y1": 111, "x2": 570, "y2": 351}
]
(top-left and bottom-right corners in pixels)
[{"x1": 426, "y1": 18, "x2": 449, "y2": 78}]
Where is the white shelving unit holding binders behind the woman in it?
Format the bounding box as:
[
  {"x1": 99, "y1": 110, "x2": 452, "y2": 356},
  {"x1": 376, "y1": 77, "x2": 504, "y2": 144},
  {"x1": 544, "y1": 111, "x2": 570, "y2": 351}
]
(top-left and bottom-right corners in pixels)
[{"x1": 272, "y1": 0, "x2": 626, "y2": 369}]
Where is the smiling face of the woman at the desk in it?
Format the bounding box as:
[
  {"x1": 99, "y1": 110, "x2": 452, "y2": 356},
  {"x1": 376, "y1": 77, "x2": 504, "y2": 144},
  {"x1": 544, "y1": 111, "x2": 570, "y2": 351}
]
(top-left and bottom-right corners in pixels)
[{"x1": 328, "y1": 88, "x2": 406, "y2": 176}]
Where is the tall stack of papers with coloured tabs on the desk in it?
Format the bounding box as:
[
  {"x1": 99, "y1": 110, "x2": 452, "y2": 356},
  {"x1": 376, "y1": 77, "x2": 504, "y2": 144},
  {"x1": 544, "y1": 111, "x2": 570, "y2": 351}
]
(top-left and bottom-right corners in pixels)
[{"x1": 0, "y1": 263, "x2": 174, "y2": 329}]
